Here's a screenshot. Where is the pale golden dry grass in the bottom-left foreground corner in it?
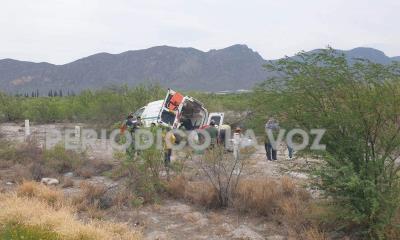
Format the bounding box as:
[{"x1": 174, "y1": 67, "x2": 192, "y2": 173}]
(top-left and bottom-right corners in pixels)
[{"x1": 0, "y1": 192, "x2": 141, "y2": 240}]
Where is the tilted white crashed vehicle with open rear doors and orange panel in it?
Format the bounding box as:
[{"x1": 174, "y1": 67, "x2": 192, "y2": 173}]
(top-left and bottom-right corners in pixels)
[{"x1": 134, "y1": 89, "x2": 224, "y2": 131}]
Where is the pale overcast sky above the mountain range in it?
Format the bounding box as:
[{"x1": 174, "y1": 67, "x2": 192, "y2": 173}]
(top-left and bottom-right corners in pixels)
[{"x1": 0, "y1": 0, "x2": 400, "y2": 64}]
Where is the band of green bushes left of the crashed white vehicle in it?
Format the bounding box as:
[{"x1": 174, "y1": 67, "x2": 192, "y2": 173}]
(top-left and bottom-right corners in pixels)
[{"x1": 0, "y1": 85, "x2": 165, "y2": 124}]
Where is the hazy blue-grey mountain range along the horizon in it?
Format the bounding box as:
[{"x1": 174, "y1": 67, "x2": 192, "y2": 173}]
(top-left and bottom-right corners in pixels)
[{"x1": 0, "y1": 45, "x2": 400, "y2": 95}]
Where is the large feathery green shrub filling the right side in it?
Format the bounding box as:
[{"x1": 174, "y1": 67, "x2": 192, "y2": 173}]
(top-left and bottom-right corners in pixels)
[{"x1": 254, "y1": 49, "x2": 400, "y2": 239}]
